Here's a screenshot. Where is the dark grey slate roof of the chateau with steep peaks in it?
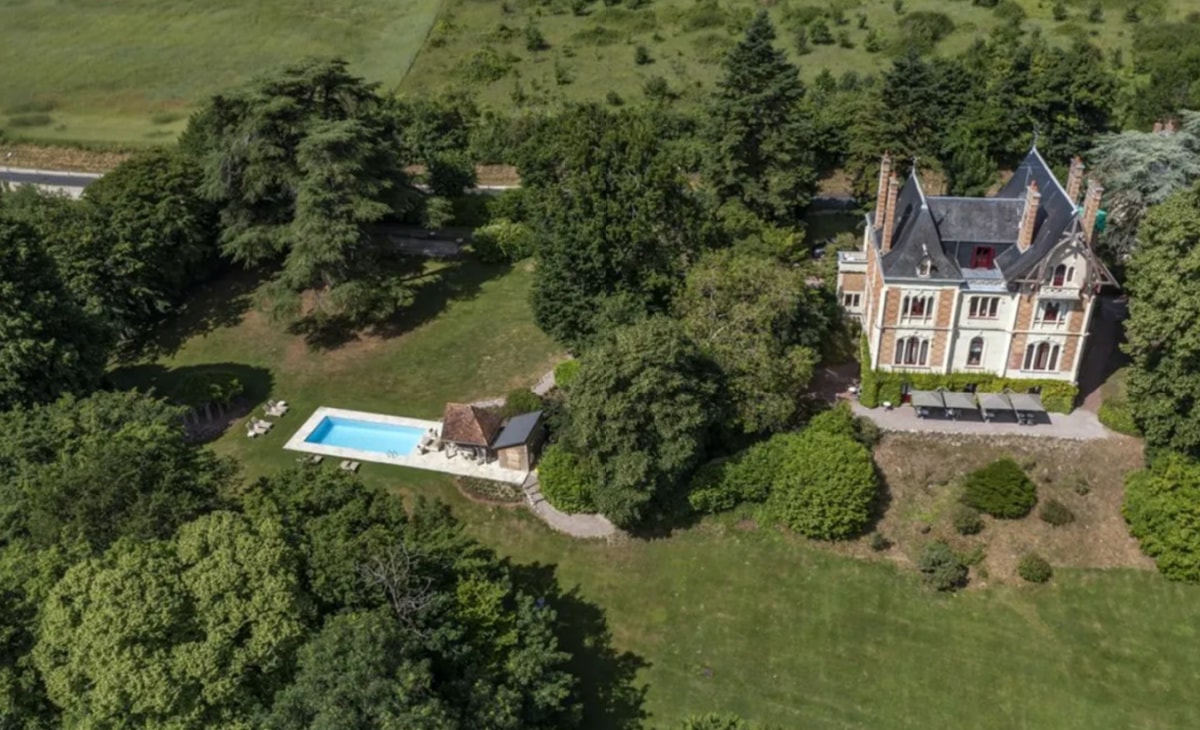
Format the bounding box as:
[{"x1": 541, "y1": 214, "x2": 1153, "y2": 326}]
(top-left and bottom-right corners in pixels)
[{"x1": 868, "y1": 149, "x2": 1079, "y2": 283}]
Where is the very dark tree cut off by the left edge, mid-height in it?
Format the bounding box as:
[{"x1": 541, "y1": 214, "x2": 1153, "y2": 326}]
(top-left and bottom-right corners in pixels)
[{"x1": 0, "y1": 216, "x2": 109, "y2": 412}]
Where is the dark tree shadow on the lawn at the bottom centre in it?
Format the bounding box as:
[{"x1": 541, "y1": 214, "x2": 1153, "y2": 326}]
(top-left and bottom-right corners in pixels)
[{"x1": 510, "y1": 563, "x2": 649, "y2": 730}]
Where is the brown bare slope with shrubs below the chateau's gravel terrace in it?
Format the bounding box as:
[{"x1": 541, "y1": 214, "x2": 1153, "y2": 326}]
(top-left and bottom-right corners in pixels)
[{"x1": 834, "y1": 433, "x2": 1154, "y2": 586}]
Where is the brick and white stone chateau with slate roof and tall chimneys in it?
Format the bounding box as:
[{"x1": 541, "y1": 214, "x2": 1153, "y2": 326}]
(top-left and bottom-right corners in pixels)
[{"x1": 838, "y1": 149, "x2": 1115, "y2": 382}]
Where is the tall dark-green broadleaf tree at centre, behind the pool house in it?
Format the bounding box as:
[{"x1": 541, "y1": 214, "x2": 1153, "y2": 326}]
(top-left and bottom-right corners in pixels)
[{"x1": 521, "y1": 106, "x2": 702, "y2": 349}]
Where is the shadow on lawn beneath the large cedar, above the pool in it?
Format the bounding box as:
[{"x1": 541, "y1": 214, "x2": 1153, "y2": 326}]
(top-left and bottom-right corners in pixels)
[{"x1": 288, "y1": 257, "x2": 510, "y2": 351}]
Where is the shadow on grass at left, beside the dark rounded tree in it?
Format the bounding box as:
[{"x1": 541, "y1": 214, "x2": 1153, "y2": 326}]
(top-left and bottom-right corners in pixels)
[{"x1": 118, "y1": 269, "x2": 268, "y2": 363}]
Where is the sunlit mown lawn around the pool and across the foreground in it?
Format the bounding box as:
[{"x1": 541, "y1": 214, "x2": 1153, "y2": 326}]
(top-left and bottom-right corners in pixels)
[{"x1": 114, "y1": 263, "x2": 1200, "y2": 730}]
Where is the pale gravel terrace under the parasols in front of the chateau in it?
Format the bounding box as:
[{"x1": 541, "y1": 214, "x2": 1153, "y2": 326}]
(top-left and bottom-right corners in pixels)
[{"x1": 851, "y1": 401, "x2": 1112, "y2": 441}]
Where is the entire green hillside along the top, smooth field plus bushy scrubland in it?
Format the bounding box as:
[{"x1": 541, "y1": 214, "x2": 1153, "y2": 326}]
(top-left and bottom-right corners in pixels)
[{"x1": 0, "y1": 0, "x2": 1195, "y2": 146}]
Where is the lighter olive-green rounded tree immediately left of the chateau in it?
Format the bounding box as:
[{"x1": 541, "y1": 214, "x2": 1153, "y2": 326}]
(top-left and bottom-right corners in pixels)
[{"x1": 673, "y1": 251, "x2": 829, "y2": 433}]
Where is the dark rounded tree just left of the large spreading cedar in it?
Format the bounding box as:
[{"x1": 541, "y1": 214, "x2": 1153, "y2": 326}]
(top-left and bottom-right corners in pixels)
[{"x1": 77, "y1": 149, "x2": 217, "y2": 340}]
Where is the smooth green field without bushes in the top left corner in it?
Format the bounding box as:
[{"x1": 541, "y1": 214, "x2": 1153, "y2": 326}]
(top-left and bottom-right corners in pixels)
[{"x1": 0, "y1": 0, "x2": 440, "y2": 143}]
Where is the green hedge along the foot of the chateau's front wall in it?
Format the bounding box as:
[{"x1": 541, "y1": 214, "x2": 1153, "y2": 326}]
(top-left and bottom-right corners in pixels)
[{"x1": 858, "y1": 337, "x2": 1079, "y2": 413}]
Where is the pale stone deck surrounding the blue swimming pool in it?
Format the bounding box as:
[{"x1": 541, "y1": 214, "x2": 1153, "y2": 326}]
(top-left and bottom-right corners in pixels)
[{"x1": 283, "y1": 406, "x2": 528, "y2": 484}]
